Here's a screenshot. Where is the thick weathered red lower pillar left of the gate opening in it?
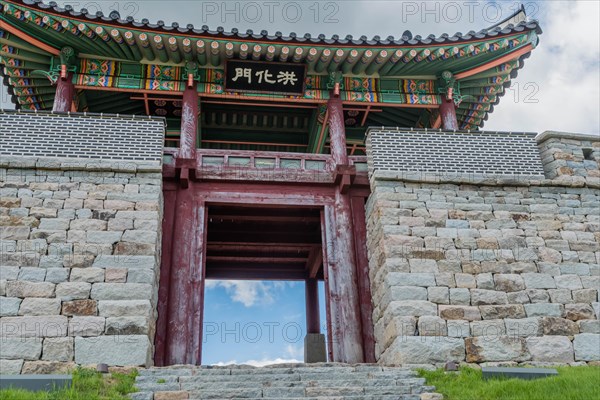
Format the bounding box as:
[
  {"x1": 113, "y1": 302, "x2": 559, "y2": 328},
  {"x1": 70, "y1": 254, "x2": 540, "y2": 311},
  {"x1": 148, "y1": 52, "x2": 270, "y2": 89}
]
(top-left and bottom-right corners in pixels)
[{"x1": 164, "y1": 188, "x2": 206, "y2": 365}]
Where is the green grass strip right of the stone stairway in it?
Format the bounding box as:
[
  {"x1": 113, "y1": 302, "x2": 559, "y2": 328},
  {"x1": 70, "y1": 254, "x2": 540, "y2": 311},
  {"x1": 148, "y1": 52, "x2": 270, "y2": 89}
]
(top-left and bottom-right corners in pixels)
[{"x1": 419, "y1": 367, "x2": 600, "y2": 400}]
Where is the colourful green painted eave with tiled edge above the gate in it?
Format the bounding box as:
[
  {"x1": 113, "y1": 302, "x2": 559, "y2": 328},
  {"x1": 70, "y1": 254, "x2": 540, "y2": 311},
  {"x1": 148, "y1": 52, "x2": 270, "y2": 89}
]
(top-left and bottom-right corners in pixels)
[{"x1": 0, "y1": 0, "x2": 541, "y2": 129}]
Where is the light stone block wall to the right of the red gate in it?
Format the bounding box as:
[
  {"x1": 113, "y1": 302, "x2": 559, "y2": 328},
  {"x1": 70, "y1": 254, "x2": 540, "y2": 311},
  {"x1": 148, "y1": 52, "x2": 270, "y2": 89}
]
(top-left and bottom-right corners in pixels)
[{"x1": 367, "y1": 129, "x2": 600, "y2": 364}]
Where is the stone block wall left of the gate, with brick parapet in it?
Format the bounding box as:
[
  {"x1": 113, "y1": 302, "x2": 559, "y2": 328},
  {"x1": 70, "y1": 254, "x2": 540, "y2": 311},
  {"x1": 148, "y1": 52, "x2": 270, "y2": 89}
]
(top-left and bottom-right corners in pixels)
[{"x1": 0, "y1": 112, "x2": 164, "y2": 374}]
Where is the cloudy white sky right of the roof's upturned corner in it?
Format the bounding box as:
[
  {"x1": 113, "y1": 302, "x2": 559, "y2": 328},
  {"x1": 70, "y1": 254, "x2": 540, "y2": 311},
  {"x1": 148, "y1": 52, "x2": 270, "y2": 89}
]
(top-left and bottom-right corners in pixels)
[{"x1": 484, "y1": 1, "x2": 600, "y2": 134}]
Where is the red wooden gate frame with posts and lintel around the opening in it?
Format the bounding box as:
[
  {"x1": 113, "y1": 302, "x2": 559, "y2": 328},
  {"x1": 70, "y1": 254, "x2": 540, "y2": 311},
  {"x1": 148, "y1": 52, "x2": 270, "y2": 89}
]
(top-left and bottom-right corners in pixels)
[{"x1": 154, "y1": 179, "x2": 374, "y2": 366}]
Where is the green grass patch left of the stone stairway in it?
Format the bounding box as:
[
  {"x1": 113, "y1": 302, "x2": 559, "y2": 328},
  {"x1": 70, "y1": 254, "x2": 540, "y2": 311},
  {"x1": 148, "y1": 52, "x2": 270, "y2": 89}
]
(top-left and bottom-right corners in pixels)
[{"x1": 0, "y1": 368, "x2": 137, "y2": 400}]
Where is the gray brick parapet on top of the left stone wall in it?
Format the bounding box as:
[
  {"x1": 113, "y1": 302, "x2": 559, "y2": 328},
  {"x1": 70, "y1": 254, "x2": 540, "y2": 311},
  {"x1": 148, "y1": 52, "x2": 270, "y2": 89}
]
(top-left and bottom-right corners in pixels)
[{"x1": 0, "y1": 110, "x2": 165, "y2": 163}]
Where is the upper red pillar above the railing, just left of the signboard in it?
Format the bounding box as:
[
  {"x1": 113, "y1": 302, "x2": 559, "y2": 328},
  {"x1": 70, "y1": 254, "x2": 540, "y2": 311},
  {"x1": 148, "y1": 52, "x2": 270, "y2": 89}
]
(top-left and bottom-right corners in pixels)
[{"x1": 179, "y1": 81, "x2": 200, "y2": 159}]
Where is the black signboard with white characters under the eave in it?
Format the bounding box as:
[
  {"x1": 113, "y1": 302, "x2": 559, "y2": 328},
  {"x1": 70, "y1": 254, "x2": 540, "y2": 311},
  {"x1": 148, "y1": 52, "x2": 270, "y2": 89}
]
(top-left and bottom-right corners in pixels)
[{"x1": 225, "y1": 60, "x2": 306, "y2": 96}]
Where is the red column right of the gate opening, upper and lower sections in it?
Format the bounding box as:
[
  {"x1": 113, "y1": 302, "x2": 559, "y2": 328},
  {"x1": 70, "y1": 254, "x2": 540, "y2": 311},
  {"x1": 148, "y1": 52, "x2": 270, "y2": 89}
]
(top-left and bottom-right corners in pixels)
[{"x1": 327, "y1": 92, "x2": 364, "y2": 363}]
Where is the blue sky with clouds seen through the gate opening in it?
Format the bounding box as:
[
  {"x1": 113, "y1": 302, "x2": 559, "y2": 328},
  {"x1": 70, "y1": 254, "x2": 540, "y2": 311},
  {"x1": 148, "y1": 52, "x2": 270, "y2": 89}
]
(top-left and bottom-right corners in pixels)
[{"x1": 202, "y1": 281, "x2": 326, "y2": 365}]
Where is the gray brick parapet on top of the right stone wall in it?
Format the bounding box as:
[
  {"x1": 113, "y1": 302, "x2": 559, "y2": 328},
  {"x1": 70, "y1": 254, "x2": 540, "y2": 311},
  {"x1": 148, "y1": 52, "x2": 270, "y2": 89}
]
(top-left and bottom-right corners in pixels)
[{"x1": 367, "y1": 128, "x2": 544, "y2": 177}]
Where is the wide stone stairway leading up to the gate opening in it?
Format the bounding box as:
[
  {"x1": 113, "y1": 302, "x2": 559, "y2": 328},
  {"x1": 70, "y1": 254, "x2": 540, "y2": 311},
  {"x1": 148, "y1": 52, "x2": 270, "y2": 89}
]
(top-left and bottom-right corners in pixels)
[{"x1": 131, "y1": 363, "x2": 441, "y2": 400}]
